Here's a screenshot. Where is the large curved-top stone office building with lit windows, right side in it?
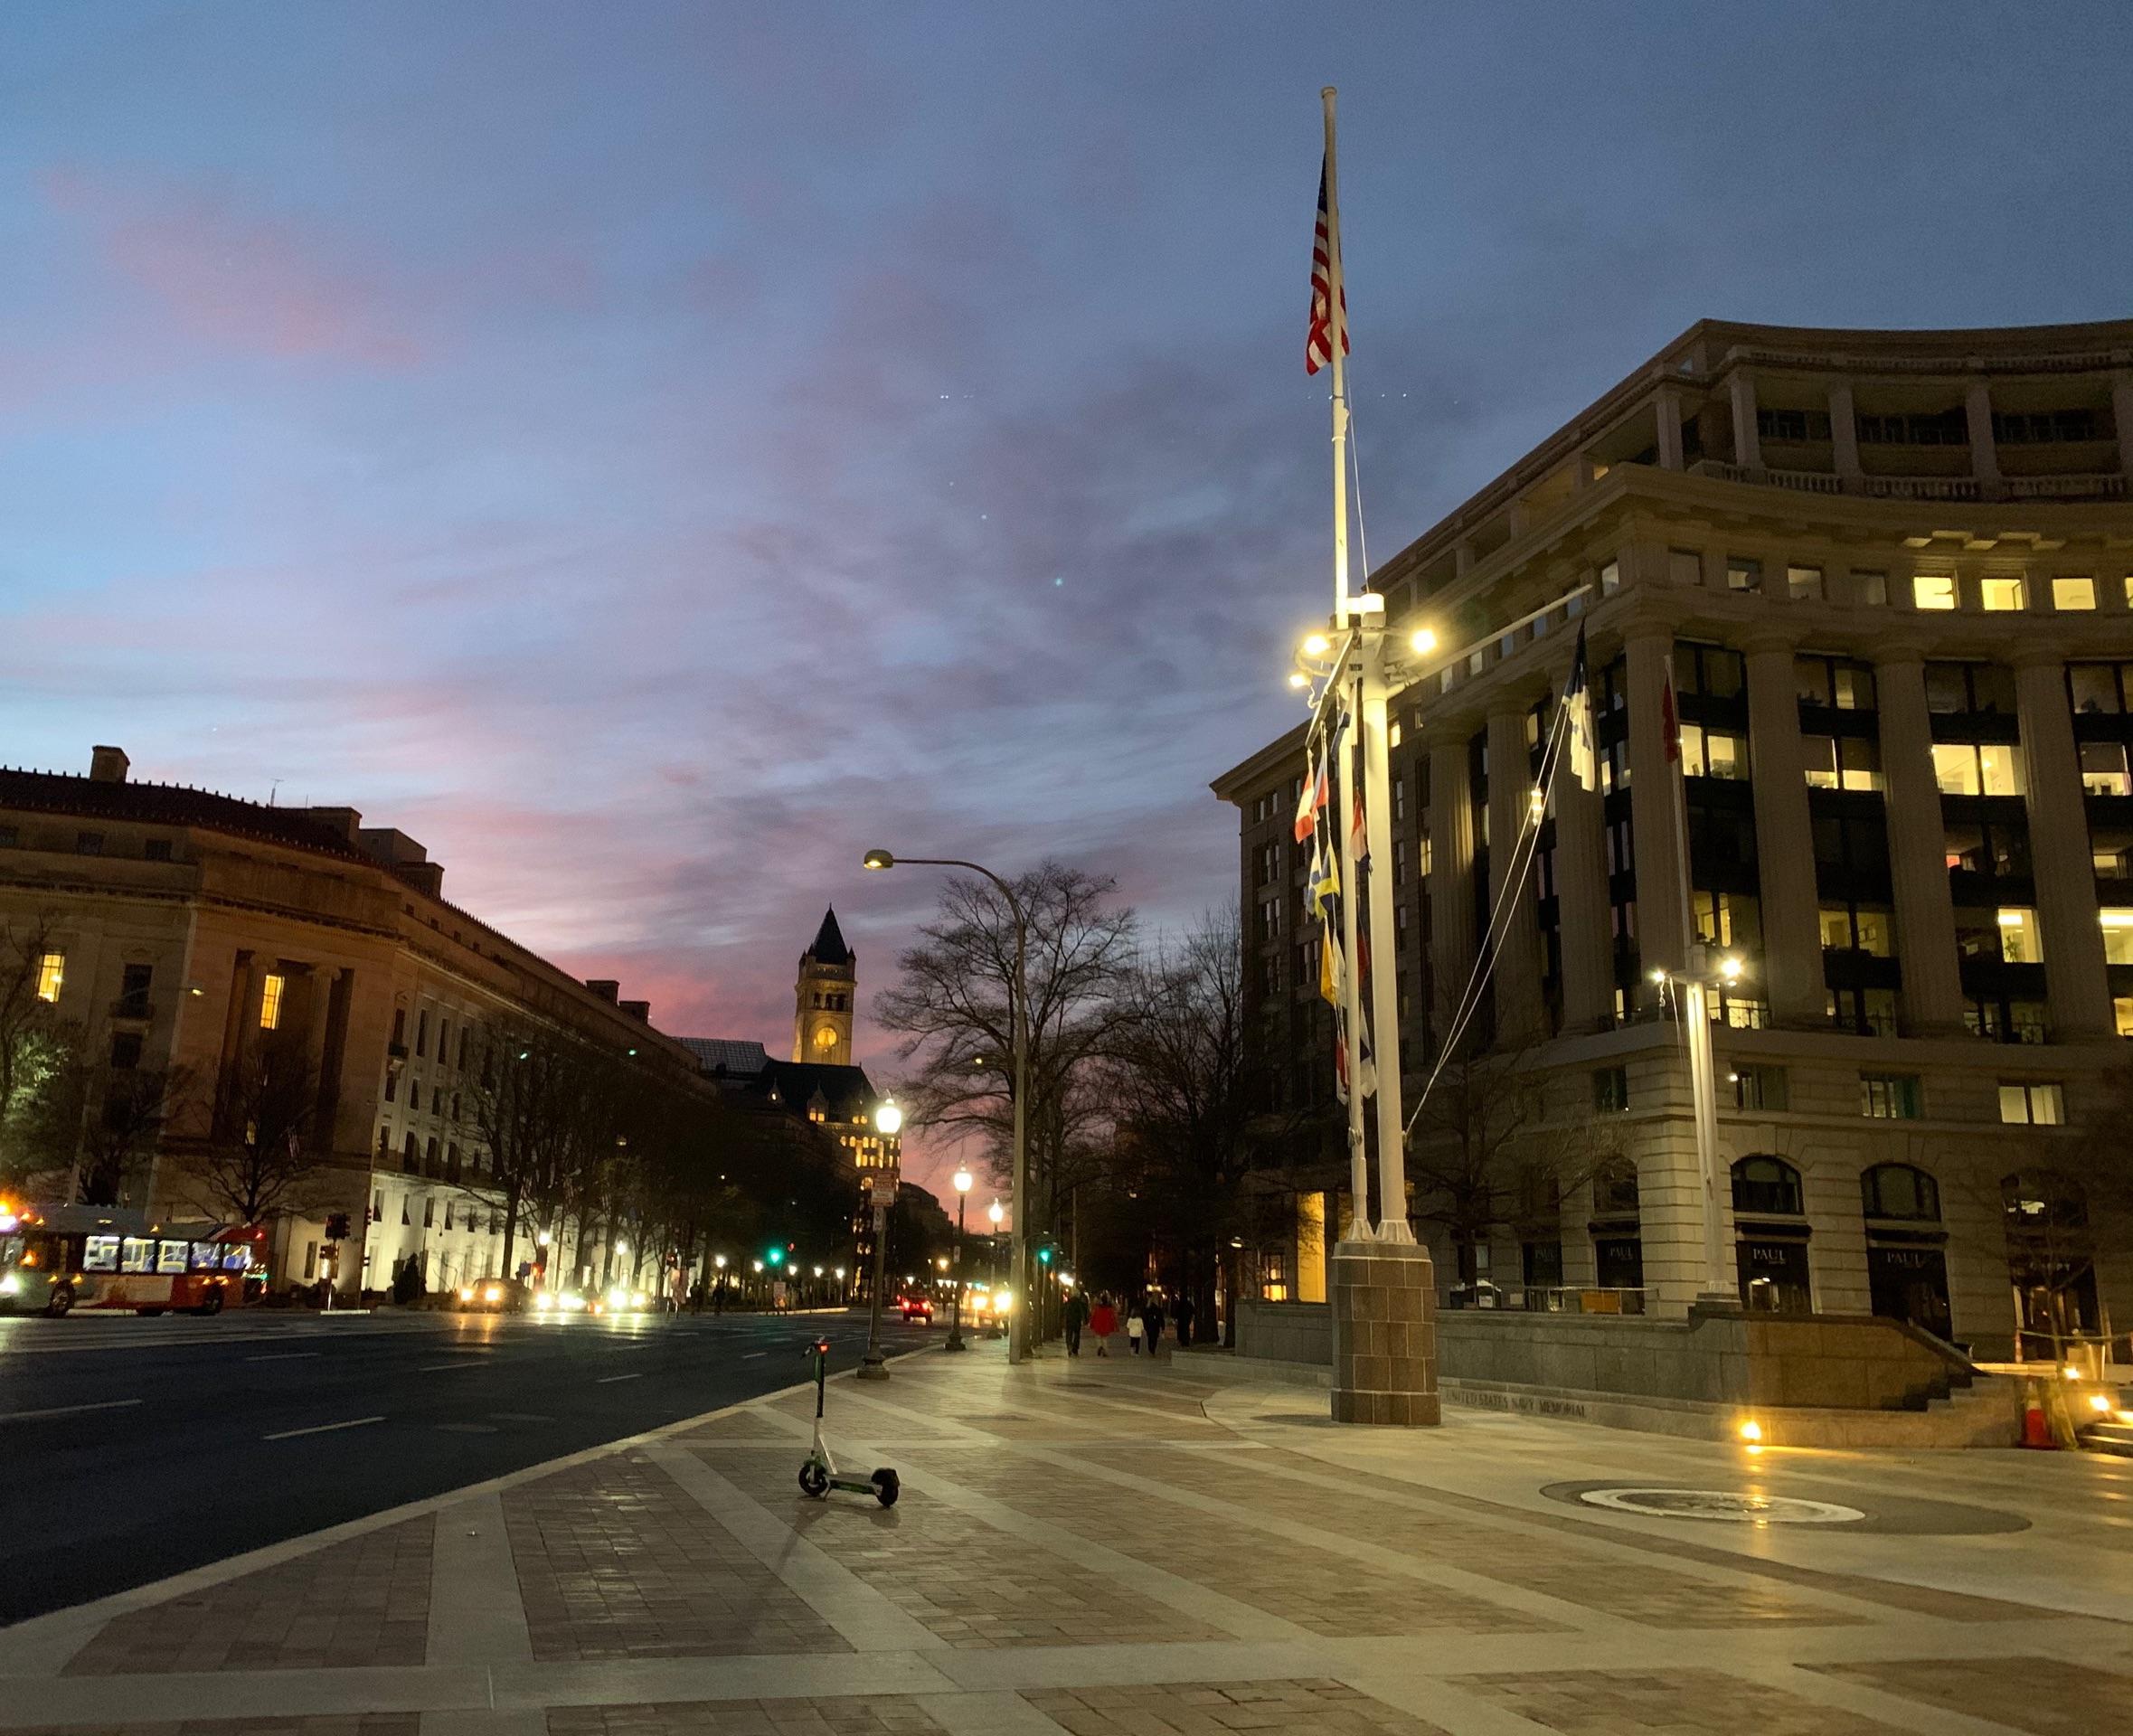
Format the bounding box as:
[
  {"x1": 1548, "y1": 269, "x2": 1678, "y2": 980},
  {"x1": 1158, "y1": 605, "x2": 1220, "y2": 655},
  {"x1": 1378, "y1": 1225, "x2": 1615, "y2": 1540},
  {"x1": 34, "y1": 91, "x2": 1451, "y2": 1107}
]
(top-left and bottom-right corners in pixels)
[{"x1": 1213, "y1": 322, "x2": 2133, "y2": 1354}]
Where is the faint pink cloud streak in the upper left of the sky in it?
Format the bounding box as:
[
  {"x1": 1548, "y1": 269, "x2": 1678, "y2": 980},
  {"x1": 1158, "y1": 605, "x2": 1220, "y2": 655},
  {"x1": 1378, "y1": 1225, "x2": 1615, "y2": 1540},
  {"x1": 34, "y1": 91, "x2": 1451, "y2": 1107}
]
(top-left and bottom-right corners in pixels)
[{"x1": 45, "y1": 168, "x2": 420, "y2": 369}]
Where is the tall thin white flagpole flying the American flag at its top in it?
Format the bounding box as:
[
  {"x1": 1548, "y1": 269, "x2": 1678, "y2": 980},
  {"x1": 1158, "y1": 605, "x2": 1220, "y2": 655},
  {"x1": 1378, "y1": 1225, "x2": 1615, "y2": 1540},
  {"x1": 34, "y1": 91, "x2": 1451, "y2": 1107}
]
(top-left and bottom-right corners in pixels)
[{"x1": 1318, "y1": 85, "x2": 1369, "y2": 1241}]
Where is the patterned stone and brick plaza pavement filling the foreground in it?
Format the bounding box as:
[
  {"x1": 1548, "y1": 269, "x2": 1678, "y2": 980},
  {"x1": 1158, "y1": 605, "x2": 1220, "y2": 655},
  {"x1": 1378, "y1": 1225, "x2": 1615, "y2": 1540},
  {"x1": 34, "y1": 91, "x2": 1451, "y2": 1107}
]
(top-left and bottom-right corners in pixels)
[{"x1": 0, "y1": 1344, "x2": 2133, "y2": 1736}]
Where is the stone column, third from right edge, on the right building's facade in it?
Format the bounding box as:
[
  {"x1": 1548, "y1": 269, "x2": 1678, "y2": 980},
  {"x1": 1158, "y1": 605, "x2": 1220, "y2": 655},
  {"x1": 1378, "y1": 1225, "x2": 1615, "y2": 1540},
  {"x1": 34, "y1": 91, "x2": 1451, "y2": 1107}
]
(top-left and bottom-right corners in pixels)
[{"x1": 1747, "y1": 637, "x2": 1826, "y2": 1028}]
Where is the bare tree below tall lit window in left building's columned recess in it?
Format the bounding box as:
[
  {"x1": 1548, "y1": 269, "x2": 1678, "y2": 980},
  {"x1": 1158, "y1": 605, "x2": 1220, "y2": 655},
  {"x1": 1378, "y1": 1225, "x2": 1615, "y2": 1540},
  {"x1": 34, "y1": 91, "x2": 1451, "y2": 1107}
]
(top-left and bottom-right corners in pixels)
[{"x1": 185, "y1": 1036, "x2": 328, "y2": 1224}]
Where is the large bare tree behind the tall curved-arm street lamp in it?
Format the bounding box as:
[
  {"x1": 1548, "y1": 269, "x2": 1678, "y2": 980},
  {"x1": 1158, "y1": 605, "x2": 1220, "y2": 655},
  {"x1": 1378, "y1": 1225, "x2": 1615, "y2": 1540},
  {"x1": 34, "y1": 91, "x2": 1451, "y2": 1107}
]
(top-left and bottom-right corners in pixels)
[{"x1": 874, "y1": 862, "x2": 1137, "y2": 1224}]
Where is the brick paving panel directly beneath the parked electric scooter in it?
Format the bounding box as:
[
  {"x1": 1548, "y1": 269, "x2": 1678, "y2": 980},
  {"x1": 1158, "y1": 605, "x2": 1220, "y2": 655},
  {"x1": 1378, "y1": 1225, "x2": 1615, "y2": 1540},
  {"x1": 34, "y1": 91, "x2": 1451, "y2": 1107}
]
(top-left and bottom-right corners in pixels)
[{"x1": 703, "y1": 1452, "x2": 1226, "y2": 1651}]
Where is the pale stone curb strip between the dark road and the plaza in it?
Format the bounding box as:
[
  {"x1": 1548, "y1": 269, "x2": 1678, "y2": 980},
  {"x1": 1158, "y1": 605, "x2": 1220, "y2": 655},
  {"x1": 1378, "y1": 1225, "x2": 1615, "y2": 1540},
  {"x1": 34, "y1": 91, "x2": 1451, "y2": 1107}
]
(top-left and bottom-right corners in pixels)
[{"x1": 0, "y1": 1350, "x2": 923, "y2": 1683}]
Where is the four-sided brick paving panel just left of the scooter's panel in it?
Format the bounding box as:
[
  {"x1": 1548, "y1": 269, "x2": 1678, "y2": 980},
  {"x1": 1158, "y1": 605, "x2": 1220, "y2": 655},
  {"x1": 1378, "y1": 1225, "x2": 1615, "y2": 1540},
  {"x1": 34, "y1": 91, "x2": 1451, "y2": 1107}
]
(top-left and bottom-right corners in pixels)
[{"x1": 504, "y1": 1455, "x2": 851, "y2": 1664}]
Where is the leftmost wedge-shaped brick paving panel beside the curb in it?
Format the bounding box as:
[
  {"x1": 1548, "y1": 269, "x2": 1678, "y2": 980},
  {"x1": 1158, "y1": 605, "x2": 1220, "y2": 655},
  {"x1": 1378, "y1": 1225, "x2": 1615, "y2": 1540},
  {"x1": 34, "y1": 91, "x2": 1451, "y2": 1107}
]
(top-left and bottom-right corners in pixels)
[{"x1": 66, "y1": 1514, "x2": 435, "y2": 1676}]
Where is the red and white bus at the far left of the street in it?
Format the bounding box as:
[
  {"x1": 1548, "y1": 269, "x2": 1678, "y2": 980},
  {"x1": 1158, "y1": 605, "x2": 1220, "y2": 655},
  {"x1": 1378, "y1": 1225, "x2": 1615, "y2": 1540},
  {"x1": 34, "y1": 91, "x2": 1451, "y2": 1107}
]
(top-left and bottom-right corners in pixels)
[{"x1": 0, "y1": 1201, "x2": 267, "y2": 1316}]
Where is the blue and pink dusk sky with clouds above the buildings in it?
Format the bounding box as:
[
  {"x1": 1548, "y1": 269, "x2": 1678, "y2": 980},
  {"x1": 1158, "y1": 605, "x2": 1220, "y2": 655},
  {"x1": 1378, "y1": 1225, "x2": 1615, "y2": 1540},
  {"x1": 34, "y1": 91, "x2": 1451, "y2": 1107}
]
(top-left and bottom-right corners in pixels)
[{"x1": 0, "y1": 0, "x2": 2133, "y2": 1179}]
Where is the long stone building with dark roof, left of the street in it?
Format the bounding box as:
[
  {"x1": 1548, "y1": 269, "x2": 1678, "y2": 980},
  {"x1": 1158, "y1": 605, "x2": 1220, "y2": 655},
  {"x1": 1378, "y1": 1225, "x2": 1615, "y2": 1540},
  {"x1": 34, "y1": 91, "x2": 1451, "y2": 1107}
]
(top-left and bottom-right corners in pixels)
[{"x1": 0, "y1": 747, "x2": 713, "y2": 1292}]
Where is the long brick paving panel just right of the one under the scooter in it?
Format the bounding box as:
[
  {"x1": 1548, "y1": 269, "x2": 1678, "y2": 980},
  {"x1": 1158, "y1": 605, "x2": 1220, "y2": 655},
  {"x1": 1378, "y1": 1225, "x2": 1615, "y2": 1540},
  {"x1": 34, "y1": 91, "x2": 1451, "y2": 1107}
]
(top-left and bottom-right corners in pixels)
[{"x1": 923, "y1": 1448, "x2": 1551, "y2": 1636}]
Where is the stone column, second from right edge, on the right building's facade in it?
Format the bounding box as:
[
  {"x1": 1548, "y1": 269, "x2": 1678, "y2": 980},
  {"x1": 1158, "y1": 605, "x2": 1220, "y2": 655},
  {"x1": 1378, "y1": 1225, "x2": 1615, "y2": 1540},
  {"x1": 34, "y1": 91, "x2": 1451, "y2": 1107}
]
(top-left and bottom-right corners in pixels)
[{"x1": 1875, "y1": 646, "x2": 1967, "y2": 1036}]
